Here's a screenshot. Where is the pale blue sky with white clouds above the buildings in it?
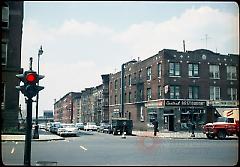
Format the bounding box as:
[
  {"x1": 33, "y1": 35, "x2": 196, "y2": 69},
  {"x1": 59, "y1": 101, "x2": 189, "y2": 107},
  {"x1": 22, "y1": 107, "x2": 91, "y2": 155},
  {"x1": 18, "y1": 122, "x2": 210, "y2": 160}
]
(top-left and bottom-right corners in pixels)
[{"x1": 20, "y1": 1, "x2": 239, "y2": 117}]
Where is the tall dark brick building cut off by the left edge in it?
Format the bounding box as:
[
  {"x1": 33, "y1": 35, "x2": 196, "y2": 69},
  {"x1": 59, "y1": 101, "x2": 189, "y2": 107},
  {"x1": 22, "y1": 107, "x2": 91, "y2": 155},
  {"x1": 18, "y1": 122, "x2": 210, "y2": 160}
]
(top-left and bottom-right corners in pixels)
[{"x1": 1, "y1": 1, "x2": 23, "y2": 129}]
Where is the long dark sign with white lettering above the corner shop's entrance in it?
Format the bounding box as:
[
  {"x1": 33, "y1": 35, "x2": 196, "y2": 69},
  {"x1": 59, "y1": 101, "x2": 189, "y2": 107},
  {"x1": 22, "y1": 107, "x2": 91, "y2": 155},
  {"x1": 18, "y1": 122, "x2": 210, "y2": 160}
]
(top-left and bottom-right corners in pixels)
[{"x1": 165, "y1": 100, "x2": 206, "y2": 107}]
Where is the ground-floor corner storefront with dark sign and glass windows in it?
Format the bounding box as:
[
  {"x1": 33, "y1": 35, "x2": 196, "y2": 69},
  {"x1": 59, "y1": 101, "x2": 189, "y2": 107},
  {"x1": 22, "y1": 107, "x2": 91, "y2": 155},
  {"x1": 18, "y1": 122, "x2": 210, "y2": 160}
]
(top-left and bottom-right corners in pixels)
[{"x1": 145, "y1": 100, "x2": 207, "y2": 131}]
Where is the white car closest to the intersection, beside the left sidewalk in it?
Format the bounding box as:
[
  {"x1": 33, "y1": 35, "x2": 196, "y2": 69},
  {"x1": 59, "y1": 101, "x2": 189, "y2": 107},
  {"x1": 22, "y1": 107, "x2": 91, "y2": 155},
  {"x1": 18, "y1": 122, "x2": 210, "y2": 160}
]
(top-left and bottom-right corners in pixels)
[{"x1": 57, "y1": 124, "x2": 78, "y2": 136}]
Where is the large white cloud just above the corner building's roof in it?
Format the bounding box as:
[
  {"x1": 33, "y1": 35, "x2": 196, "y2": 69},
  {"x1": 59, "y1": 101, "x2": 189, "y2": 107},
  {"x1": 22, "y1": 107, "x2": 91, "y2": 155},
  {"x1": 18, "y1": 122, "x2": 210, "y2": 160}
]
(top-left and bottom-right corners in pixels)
[{"x1": 113, "y1": 7, "x2": 239, "y2": 58}]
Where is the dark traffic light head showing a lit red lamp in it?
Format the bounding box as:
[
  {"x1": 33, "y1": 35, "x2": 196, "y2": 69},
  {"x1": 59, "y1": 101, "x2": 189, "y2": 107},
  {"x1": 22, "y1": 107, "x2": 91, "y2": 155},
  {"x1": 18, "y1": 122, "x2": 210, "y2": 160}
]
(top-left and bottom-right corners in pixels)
[{"x1": 16, "y1": 70, "x2": 44, "y2": 98}]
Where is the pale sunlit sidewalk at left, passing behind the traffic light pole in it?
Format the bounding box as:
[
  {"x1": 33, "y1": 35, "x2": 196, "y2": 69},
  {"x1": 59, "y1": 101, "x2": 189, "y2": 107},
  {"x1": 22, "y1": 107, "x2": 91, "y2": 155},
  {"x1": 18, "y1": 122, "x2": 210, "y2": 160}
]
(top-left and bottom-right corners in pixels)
[{"x1": 1, "y1": 135, "x2": 64, "y2": 141}]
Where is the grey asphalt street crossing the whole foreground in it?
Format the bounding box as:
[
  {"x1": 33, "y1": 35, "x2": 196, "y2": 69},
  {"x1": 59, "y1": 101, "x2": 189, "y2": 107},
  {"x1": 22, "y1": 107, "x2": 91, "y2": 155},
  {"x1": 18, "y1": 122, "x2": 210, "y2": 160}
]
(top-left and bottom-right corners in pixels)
[{"x1": 2, "y1": 131, "x2": 239, "y2": 166}]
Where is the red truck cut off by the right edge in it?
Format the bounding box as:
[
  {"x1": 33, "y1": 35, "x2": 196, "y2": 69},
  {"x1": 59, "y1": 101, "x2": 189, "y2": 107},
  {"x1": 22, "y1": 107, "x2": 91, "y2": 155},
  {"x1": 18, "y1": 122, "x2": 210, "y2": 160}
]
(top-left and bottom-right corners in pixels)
[{"x1": 203, "y1": 110, "x2": 239, "y2": 139}]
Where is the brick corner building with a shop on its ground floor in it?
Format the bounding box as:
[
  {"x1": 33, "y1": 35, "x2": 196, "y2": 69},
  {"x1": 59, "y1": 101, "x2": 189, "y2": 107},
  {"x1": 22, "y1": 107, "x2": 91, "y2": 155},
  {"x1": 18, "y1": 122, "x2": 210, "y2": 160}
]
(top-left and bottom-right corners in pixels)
[{"x1": 109, "y1": 49, "x2": 239, "y2": 131}]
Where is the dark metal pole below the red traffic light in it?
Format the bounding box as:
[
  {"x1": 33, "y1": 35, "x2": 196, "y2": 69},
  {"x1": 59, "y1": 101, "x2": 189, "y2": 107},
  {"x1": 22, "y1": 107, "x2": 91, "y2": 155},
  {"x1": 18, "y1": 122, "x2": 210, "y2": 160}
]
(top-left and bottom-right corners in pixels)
[{"x1": 24, "y1": 98, "x2": 32, "y2": 166}]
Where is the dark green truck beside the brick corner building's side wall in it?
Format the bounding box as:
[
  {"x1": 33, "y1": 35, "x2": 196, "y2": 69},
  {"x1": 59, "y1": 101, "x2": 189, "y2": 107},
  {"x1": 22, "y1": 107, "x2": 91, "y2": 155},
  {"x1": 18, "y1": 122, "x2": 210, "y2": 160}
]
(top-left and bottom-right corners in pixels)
[{"x1": 109, "y1": 118, "x2": 133, "y2": 135}]
